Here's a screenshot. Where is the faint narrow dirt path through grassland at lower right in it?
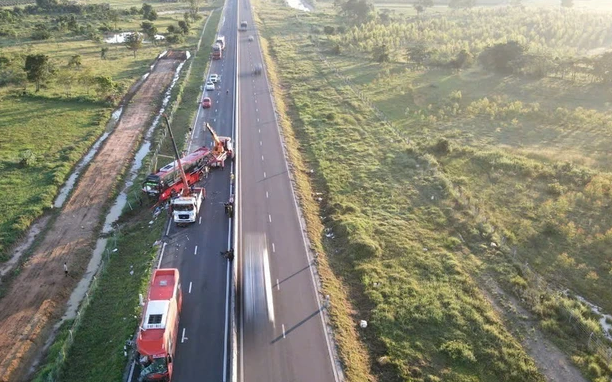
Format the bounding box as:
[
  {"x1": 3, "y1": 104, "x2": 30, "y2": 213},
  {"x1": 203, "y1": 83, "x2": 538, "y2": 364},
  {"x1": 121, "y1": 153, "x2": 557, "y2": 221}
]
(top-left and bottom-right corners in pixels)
[{"x1": 485, "y1": 279, "x2": 588, "y2": 382}]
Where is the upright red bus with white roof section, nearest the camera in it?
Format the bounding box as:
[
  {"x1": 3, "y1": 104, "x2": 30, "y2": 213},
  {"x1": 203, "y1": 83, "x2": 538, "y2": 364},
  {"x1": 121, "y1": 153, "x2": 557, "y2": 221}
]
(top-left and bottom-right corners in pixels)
[{"x1": 136, "y1": 268, "x2": 183, "y2": 382}]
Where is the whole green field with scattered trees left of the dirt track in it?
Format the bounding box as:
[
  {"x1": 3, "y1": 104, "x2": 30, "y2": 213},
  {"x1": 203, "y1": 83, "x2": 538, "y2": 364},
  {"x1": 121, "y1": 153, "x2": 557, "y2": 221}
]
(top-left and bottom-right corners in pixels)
[{"x1": 0, "y1": 0, "x2": 208, "y2": 262}]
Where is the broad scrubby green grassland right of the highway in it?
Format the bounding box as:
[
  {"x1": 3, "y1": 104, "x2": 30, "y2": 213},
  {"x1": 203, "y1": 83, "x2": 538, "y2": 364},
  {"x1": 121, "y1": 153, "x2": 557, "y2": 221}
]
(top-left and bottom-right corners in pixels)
[{"x1": 258, "y1": 0, "x2": 612, "y2": 382}]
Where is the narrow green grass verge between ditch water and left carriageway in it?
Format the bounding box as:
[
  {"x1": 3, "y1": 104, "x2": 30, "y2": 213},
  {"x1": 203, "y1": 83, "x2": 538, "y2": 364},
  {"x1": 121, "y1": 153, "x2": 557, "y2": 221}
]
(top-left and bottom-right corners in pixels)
[{"x1": 30, "y1": 3, "x2": 222, "y2": 382}]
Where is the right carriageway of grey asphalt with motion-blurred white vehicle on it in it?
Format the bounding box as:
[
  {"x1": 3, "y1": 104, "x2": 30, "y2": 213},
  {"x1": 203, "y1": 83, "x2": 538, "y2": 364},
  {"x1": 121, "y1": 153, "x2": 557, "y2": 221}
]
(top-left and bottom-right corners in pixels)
[{"x1": 237, "y1": 0, "x2": 337, "y2": 382}]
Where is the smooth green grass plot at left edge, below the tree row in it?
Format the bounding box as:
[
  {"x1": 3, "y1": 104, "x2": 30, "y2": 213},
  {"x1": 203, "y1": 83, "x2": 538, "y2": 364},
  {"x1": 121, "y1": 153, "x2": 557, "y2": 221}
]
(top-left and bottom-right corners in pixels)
[{"x1": 0, "y1": 97, "x2": 110, "y2": 260}]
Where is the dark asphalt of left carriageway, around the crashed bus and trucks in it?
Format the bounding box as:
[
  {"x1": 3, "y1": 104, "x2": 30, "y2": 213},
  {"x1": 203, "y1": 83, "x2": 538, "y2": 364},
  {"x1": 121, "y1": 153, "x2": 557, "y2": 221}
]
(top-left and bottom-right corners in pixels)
[{"x1": 153, "y1": 0, "x2": 240, "y2": 382}]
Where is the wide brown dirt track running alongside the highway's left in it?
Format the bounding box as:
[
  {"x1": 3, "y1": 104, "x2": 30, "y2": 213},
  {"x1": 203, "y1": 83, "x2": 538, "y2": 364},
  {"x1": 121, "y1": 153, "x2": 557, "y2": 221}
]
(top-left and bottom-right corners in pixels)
[{"x1": 0, "y1": 52, "x2": 184, "y2": 382}]
